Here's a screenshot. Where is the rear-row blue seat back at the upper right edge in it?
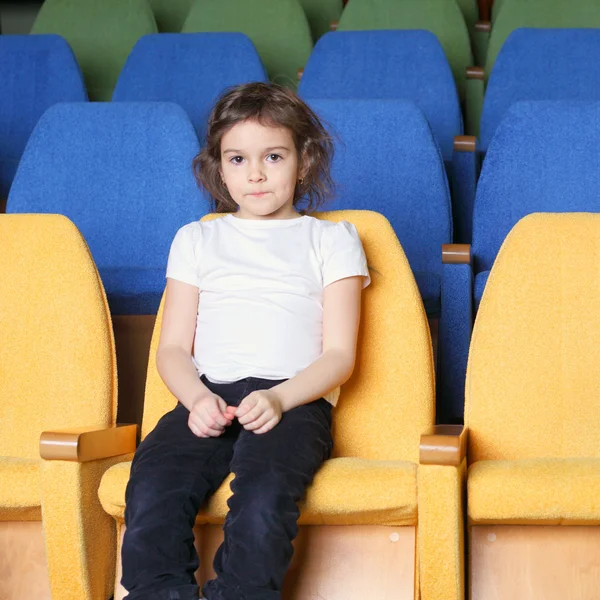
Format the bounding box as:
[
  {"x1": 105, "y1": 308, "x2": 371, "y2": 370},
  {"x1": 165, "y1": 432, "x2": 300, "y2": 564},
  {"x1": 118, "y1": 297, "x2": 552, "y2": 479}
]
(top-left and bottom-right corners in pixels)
[{"x1": 480, "y1": 29, "x2": 600, "y2": 151}]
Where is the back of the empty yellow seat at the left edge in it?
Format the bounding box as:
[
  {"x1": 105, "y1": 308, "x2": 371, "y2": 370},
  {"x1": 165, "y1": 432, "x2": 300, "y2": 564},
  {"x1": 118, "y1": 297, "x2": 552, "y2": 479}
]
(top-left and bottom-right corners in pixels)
[{"x1": 0, "y1": 215, "x2": 117, "y2": 458}]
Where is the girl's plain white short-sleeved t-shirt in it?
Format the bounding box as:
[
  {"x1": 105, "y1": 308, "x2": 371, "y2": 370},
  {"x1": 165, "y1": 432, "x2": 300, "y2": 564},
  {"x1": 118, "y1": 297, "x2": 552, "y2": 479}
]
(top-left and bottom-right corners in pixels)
[{"x1": 167, "y1": 214, "x2": 370, "y2": 404}]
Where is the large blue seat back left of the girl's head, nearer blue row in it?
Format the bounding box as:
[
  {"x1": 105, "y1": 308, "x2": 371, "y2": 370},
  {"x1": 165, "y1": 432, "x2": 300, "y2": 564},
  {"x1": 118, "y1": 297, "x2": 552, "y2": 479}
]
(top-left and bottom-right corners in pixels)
[{"x1": 7, "y1": 102, "x2": 208, "y2": 314}]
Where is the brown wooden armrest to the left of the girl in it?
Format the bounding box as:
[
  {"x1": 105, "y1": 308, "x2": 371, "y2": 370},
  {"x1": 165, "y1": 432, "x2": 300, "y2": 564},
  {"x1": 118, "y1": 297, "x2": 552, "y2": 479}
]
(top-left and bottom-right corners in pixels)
[{"x1": 40, "y1": 425, "x2": 137, "y2": 462}]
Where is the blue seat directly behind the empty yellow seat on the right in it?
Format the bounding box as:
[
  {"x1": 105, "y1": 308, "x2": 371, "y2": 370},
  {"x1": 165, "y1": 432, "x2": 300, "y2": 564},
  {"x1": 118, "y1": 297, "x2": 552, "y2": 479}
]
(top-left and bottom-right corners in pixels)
[{"x1": 444, "y1": 101, "x2": 600, "y2": 424}]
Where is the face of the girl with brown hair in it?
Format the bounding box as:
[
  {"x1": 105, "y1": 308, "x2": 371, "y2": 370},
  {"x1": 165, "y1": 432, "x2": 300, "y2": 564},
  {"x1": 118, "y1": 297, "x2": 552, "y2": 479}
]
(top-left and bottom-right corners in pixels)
[{"x1": 221, "y1": 121, "x2": 301, "y2": 219}]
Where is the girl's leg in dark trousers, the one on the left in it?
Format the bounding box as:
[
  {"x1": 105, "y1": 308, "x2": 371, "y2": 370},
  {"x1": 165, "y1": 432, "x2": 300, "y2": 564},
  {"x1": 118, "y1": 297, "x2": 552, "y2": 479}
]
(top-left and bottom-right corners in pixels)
[{"x1": 122, "y1": 404, "x2": 239, "y2": 600}]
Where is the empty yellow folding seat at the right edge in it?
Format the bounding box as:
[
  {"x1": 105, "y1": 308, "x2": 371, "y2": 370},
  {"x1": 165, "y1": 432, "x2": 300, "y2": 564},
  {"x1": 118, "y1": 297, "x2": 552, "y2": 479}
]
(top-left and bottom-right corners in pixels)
[{"x1": 465, "y1": 212, "x2": 600, "y2": 600}]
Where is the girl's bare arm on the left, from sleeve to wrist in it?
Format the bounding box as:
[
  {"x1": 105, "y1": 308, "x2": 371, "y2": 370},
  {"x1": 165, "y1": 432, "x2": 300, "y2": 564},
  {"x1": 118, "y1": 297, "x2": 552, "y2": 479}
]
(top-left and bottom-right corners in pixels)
[{"x1": 156, "y1": 278, "x2": 212, "y2": 411}]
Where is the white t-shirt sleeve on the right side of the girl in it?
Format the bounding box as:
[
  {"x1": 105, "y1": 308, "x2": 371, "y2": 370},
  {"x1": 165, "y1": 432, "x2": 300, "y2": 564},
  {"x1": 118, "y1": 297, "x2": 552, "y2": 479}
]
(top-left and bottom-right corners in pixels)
[{"x1": 322, "y1": 221, "x2": 371, "y2": 288}]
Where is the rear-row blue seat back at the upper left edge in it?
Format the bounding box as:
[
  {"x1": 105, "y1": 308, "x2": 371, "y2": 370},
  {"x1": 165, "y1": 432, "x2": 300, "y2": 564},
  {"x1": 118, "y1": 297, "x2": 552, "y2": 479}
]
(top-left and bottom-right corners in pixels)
[{"x1": 0, "y1": 35, "x2": 87, "y2": 212}]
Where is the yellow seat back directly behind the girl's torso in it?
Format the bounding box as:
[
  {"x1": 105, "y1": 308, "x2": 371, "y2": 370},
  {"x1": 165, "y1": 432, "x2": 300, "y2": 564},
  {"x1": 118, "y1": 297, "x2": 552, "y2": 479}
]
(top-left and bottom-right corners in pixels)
[{"x1": 142, "y1": 211, "x2": 435, "y2": 462}]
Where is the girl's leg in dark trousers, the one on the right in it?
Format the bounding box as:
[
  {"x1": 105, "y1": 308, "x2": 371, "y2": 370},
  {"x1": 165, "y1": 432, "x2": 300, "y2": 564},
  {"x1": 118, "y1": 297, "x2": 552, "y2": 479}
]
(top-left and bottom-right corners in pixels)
[{"x1": 203, "y1": 396, "x2": 333, "y2": 600}]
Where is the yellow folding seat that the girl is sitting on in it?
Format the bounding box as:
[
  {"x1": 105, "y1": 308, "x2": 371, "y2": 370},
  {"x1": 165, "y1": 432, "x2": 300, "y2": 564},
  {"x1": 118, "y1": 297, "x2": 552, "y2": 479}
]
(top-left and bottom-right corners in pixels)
[{"x1": 99, "y1": 211, "x2": 465, "y2": 600}]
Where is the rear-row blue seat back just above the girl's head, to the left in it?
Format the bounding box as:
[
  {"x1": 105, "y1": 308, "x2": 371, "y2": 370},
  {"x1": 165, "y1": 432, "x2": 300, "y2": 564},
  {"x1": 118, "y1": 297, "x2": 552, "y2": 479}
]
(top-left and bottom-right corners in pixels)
[{"x1": 112, "y1": 33, "x2": 268, "y2": 139}]
